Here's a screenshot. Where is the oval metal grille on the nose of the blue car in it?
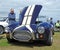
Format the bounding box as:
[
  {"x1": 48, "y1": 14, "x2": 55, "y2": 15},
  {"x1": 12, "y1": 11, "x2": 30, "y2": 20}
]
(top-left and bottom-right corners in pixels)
[{"x1": 13, "y1": 31, "x2": 32, "y2": 41}]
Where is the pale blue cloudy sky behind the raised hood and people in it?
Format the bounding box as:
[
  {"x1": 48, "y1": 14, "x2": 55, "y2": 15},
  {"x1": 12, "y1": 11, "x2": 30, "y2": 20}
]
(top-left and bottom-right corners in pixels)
[{"x1": 0, "y1": 0, "x2": 60, "y2": 21}]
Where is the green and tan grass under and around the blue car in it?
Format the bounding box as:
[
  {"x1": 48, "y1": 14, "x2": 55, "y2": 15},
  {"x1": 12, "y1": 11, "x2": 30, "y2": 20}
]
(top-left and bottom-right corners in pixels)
[{"x1": 0, "y1": 32, "x2": 60, "y2": 50}]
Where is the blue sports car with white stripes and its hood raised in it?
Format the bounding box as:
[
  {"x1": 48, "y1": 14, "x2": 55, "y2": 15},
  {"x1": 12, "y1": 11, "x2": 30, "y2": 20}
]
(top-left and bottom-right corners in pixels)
[{"x1": 6, "y1": 5, "x2": 53, "y2": 45}]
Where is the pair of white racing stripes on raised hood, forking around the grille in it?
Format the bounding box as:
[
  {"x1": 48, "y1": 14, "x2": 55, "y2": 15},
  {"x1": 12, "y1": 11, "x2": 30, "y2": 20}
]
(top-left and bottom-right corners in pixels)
[{"x1": 14, "y1": 5, "x2": 35, "y2": 32}]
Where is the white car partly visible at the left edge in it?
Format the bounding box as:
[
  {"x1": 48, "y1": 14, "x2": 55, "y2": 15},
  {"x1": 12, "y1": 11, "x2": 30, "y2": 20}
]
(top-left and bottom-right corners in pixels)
[{"x1": 0, "y1": 17, "x2": 8, "y2": 34}]
